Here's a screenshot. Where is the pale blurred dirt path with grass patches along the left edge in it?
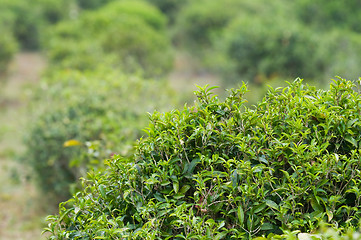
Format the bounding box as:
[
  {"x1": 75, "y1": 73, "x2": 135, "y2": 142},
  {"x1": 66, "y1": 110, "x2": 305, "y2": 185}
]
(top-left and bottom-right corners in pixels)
[{"x1": 0, "y1": 53, "x2": 45, "y2": 240}]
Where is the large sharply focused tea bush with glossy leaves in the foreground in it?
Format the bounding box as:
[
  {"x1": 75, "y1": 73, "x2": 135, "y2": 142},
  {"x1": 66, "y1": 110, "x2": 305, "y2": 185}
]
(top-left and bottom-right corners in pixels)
[{"x1": 46, "y1": 79, "x2": 361, "y2": 239}]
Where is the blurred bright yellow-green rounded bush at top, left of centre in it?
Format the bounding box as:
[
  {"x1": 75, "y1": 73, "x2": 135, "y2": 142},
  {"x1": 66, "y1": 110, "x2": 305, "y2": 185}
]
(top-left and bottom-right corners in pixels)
[{"x1": 47, "y1": 1, "x2": 172, "y2": 77}]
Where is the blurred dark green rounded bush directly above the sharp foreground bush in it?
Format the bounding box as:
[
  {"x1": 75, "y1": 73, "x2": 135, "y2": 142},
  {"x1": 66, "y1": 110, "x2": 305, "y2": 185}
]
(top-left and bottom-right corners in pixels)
[{"x1": 219, "y1": 16, "x2": 328, "y2": 82}]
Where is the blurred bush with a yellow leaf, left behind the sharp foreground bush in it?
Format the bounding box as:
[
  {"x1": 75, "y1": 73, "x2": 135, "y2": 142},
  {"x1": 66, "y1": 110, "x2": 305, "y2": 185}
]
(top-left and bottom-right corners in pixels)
[{"x1": 22, "y1": 68, "x2": 175, "y2": 201}]
